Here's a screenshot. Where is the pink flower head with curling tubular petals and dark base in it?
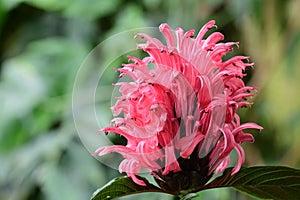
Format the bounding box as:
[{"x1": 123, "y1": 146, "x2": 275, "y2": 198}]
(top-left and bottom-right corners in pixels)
[{"x1": 94, "y1": 21, "x2": 262, "y2": 191}]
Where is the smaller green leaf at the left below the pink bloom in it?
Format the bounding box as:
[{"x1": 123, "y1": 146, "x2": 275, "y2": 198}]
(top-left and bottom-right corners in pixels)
[{"x1": 91, "y1": 176, "x2": 164, "y2": 200}]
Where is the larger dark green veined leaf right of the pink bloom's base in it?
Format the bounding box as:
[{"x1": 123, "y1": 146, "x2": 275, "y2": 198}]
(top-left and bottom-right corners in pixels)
[{"x1": 202, "y1": 166, "x2": 300, "y2": 200}]
